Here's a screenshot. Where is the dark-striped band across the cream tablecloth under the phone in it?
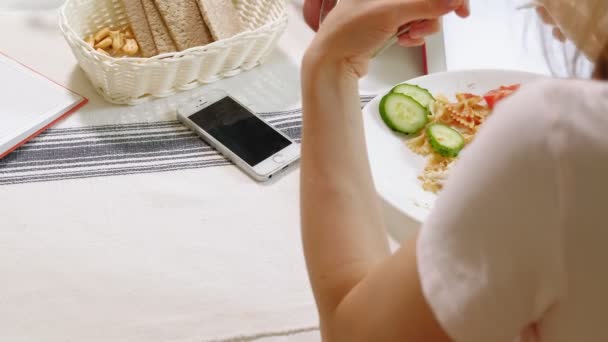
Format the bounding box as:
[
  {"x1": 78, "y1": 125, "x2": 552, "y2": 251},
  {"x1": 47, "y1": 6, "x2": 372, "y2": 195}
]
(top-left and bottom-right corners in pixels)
[{"x1": 0, "y1": 95, "x2": 374, "y2": 185}]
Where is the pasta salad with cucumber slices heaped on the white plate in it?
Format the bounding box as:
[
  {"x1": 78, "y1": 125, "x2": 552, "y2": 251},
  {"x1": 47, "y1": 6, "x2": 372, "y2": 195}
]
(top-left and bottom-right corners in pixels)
[{"x1": 380, "y1": 84, "x2": 519, "y2": 193}]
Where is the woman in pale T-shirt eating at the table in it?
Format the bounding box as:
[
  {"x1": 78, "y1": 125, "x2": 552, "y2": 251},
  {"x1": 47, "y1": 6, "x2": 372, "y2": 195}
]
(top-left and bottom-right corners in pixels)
[{"x1": 301, "y1": 0, "x2": 608, "y2": 342}]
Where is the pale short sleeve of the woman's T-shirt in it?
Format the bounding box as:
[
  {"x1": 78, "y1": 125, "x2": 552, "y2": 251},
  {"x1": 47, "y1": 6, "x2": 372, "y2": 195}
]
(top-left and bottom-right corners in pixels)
[{"x1": 417, "y1": 87, "x2": 565, "y2": 342}]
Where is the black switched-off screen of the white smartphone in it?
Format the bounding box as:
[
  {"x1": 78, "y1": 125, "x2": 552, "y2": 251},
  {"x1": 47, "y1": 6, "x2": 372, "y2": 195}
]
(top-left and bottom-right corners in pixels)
[{"x1": 188, "y1": 96, "x2": 291, "y2": 166}]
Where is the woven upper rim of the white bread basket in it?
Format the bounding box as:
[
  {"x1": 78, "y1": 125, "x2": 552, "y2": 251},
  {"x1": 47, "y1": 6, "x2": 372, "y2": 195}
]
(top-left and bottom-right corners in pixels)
[{"x1": 59, "y1": 0, "x2": 288, "y2": 64}]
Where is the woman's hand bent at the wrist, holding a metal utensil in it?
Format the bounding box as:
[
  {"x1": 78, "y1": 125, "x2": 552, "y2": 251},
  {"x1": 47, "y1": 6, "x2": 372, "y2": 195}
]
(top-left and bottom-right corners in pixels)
[{"x1": 305, "y1": 0, "x2": 469, "y2": 77}]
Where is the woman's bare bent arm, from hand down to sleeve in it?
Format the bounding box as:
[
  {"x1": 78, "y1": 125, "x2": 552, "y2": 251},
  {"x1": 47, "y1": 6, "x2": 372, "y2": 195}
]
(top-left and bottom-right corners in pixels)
[{"x1": 301, "y1": 0, "x2": 463, "y2": 342}]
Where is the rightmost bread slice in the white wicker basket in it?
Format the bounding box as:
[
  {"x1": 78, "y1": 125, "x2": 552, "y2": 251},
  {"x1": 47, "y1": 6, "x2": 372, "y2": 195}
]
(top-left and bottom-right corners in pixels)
[{"x1": 197, "y1": 0, "x2": 243, "y2": 40}]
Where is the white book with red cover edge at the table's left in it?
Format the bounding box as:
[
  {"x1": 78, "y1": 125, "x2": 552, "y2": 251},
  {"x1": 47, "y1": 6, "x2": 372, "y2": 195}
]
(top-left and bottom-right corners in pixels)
[{"x1": 0, "y1": 53, "x2": 87, "y2": 158}]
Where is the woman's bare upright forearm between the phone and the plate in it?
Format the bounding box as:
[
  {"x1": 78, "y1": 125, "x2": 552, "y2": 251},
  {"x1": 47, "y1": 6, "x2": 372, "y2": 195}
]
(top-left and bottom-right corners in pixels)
[{"x1": 301, "y1": 55, "x2": 389, "y2": 315}]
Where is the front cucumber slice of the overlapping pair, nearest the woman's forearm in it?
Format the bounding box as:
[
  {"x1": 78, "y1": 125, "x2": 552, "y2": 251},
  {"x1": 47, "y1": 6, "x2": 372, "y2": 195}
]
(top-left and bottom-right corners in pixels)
[{"x1": 380, "y1": 93, "x2": 429, "y2": 134}]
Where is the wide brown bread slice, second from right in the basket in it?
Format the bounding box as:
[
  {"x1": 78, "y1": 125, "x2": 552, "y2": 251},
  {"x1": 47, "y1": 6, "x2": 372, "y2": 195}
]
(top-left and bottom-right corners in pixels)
[{"x1": 154, "y1": 0, "x2": 213, "y2": 51}]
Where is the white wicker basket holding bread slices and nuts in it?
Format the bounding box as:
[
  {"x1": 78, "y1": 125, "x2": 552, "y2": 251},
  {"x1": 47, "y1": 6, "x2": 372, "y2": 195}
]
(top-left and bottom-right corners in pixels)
[{"x1": 59, "y1": 0, "x2": 287, "y2": 105}]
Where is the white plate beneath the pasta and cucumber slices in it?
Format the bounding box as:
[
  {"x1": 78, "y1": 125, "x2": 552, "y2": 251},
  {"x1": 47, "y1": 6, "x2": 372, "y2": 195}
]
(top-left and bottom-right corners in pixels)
[{"x1": 363, "y1": 70, "x2": 542, "y2": 223}]
